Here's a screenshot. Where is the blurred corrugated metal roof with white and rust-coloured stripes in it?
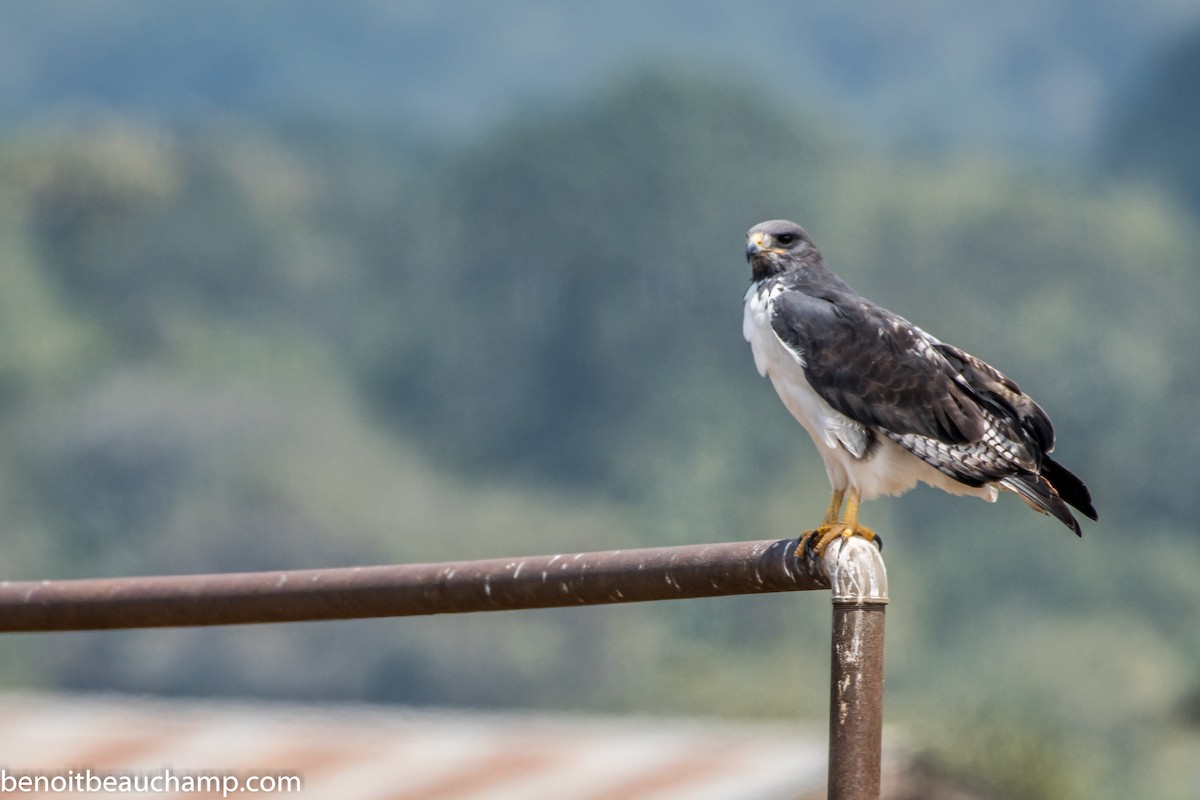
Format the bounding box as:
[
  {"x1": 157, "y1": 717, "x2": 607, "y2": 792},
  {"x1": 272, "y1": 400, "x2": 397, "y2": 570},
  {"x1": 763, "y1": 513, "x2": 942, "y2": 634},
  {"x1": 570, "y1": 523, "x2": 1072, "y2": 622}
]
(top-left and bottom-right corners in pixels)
[{"x1": 0, "y1": 694, "x2": 936, "y2": 800}]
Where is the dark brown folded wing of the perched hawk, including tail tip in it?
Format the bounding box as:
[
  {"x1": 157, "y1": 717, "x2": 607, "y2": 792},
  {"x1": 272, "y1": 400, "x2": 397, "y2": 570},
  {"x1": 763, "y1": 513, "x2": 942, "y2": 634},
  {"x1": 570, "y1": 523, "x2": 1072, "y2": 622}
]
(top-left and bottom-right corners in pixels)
[{"x1": 772, "y1": 286, "x2": 1097, "y2": 533}]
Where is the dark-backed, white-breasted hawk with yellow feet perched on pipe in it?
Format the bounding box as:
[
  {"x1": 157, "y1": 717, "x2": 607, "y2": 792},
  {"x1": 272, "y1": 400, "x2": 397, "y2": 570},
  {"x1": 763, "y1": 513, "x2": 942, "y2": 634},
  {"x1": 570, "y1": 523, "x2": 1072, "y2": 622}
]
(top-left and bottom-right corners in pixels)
[{"x1": 742, "y1": 219, "x2": 1097, "y2": 557}]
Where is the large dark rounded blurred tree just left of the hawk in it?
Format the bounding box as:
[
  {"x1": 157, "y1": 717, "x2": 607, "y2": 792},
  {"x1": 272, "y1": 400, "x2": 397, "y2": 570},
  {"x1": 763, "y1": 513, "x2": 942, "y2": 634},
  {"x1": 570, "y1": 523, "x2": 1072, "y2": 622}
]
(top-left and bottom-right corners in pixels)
[{"x1": 368, "y1": 73, "x2": 836, "y2": 513}]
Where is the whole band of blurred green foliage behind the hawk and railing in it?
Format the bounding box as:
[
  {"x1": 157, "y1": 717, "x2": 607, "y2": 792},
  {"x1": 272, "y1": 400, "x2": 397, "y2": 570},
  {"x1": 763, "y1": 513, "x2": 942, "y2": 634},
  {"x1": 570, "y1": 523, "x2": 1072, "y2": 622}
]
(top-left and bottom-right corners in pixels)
[{"x1": 0, "y1": 62, "x2": 1200, "y2": 796}]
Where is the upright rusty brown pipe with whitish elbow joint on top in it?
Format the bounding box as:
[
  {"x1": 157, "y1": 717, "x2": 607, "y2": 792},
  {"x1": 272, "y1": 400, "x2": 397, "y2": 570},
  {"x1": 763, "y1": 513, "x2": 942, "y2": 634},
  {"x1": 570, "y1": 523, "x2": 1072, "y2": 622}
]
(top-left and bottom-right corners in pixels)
[{"x1": 824, "y1": 536, "x2": 888, "y2": 800}]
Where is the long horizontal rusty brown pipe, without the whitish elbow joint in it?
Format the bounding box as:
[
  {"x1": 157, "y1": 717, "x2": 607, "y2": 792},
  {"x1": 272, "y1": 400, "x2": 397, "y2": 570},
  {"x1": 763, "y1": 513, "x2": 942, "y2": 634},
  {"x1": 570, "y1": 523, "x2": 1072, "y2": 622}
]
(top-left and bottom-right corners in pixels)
[{"x1": 0, "y1": 539, "x2": 829, "y2": 632}]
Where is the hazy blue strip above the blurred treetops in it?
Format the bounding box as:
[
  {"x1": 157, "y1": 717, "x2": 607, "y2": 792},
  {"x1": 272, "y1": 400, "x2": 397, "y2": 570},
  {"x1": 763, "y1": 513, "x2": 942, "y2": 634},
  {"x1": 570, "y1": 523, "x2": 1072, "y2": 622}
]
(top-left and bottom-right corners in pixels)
[{"x1": 0, "y1": 0, "x2": 1200, "y2": 154}]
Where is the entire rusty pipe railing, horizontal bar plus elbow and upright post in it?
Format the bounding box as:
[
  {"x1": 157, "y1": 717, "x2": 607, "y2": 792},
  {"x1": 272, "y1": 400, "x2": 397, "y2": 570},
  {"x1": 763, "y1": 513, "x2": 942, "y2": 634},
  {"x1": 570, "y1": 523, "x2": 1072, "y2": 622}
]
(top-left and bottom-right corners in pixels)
[{"x1": 0, "y1": 537, "x2": 888, "y2": 800}]
